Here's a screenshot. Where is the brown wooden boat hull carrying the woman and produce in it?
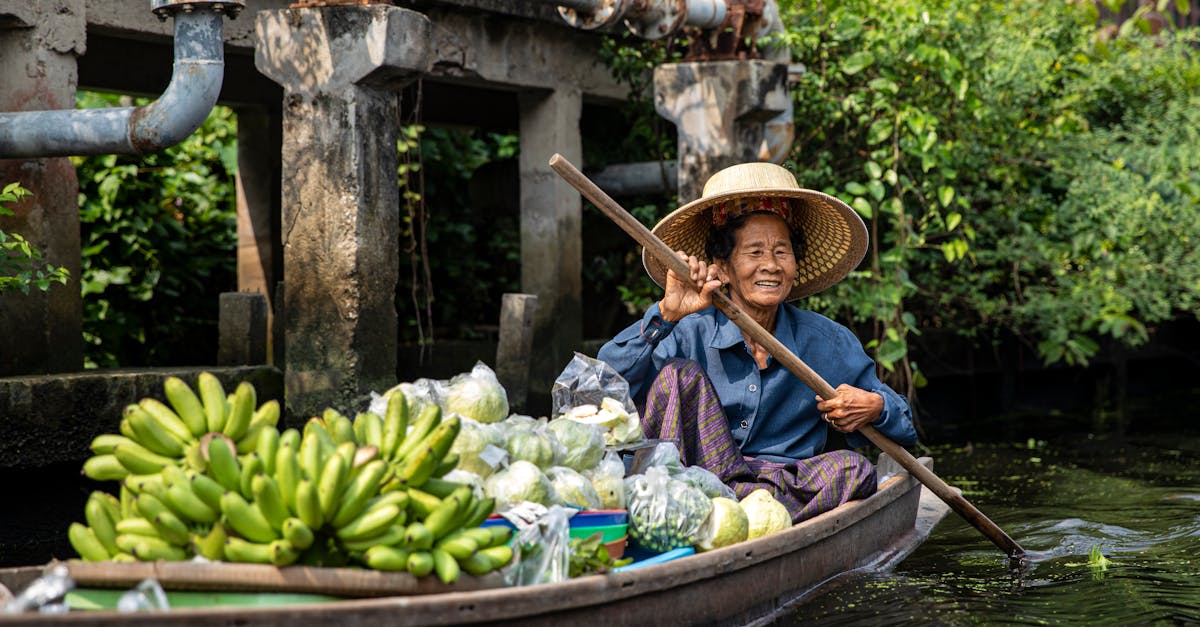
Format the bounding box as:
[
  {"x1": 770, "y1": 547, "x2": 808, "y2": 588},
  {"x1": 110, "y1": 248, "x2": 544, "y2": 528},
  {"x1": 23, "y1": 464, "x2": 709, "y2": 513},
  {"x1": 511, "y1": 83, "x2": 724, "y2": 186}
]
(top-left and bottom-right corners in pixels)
[{"x1": 0, "y1": 458, "x2": 948, "y2": 627}]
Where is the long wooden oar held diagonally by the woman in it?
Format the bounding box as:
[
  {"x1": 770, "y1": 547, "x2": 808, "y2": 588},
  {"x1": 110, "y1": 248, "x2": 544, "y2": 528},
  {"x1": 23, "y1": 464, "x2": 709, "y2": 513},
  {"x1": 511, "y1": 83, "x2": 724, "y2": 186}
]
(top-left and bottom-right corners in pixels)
[{"x1": 550, "y1": 154, "x2": 1025, "y2": 561}]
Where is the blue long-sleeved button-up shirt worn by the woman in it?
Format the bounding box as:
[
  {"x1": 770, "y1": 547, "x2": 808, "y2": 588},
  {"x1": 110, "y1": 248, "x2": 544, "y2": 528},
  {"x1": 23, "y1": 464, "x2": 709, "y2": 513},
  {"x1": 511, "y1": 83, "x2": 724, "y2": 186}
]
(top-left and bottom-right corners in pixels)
[{"x1": 598, "y1": 304, "x2": 917, "y2": 462}]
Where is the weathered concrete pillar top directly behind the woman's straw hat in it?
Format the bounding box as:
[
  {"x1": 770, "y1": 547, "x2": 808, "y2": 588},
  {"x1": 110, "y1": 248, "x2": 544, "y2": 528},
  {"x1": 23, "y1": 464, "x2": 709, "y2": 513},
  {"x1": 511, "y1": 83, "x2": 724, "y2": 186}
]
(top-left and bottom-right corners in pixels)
[{"x1": 654, "y1": 60, "x2": 792, "y2": 203}]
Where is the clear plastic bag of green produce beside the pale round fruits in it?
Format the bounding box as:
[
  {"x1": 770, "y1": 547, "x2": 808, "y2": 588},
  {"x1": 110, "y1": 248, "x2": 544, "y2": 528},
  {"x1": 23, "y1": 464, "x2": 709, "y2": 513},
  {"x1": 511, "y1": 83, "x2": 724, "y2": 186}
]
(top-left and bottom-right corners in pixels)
[{"x1": 625, "y1": 466, "x2": 713, "y2": 553}]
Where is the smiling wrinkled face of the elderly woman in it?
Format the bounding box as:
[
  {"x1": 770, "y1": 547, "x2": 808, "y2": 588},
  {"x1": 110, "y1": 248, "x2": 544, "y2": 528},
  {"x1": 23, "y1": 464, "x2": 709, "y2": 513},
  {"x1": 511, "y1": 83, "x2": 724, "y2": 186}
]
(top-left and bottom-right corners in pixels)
[{"x1": 718, "y1": 214, "x2": 797, "y2": 311}]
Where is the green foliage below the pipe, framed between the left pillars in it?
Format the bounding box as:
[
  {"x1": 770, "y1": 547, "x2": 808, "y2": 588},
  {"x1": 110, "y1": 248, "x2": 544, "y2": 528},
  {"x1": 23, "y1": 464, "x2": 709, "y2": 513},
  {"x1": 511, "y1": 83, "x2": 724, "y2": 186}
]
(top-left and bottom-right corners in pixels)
[{"x1": 73, "y1": 92, "x2": 238, "y2": 368}]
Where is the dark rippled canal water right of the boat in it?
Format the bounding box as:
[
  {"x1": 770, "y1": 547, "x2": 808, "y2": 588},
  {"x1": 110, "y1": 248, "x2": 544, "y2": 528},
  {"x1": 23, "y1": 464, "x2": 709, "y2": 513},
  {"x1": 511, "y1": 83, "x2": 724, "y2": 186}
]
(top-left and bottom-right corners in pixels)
[{"x1": 773, "y1": 432, "x2": 1200, "y2": 626}]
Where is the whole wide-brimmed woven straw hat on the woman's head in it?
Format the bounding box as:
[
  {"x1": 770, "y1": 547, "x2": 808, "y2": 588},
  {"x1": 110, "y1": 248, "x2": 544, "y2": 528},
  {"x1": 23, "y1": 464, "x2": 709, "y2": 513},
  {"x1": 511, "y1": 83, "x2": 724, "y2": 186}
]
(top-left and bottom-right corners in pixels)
[{"x1": 642, "y1": 163, "x2": 868, "y2": 300}]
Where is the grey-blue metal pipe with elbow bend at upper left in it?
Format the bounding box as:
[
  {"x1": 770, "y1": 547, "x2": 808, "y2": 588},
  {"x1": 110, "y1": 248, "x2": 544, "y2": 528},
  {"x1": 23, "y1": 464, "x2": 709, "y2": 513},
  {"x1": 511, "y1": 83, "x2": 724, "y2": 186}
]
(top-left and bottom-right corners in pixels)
[{"x1": 0, "y1": 0, "x2": 244, "y2": 159}]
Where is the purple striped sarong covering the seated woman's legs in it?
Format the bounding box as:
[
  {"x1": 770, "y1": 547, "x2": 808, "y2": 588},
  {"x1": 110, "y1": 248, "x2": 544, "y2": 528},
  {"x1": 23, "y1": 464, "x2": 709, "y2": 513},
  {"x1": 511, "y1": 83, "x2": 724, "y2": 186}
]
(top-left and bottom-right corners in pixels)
[{"x1": 642, "y1": 359, "x2": 876, "y2": 523}]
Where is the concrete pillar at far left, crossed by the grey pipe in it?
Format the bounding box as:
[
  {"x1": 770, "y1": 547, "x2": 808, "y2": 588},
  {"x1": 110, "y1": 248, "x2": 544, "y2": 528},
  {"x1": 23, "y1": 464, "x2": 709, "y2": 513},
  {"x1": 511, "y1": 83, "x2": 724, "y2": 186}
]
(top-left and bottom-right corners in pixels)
[{"x1": 0, "y1": 0, "x2": 86, "y2": 376}]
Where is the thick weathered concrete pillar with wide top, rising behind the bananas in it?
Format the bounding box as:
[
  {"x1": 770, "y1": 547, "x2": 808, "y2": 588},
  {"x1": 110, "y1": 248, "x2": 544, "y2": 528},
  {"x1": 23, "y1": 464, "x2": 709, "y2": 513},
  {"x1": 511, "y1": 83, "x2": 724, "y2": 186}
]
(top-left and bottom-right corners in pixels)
[{"x1": 254, "y1": 5, "x2": 431, "y2": 416}]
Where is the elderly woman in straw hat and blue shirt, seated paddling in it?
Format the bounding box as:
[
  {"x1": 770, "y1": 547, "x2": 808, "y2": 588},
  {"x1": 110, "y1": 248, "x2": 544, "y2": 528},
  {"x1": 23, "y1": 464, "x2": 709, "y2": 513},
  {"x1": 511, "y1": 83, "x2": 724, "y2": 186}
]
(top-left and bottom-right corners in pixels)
[{"x1": 599, "y1": 163, "x2": 917, "y2": 521}]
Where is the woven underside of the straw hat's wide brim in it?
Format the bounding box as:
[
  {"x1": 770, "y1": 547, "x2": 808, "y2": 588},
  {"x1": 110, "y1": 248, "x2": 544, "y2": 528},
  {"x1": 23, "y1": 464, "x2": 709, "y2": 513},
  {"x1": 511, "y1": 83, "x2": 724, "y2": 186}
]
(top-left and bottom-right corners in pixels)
[{"x1": 642, "y1": 187, "x2": 868, "y2": 301}]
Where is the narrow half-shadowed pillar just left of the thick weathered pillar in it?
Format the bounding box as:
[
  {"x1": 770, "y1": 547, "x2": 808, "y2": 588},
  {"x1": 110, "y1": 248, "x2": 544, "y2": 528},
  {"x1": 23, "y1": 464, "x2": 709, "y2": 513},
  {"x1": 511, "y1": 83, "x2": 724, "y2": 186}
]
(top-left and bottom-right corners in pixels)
[{"x1": 236, "y1": 107, "x2": 282, "y2": 366}]
